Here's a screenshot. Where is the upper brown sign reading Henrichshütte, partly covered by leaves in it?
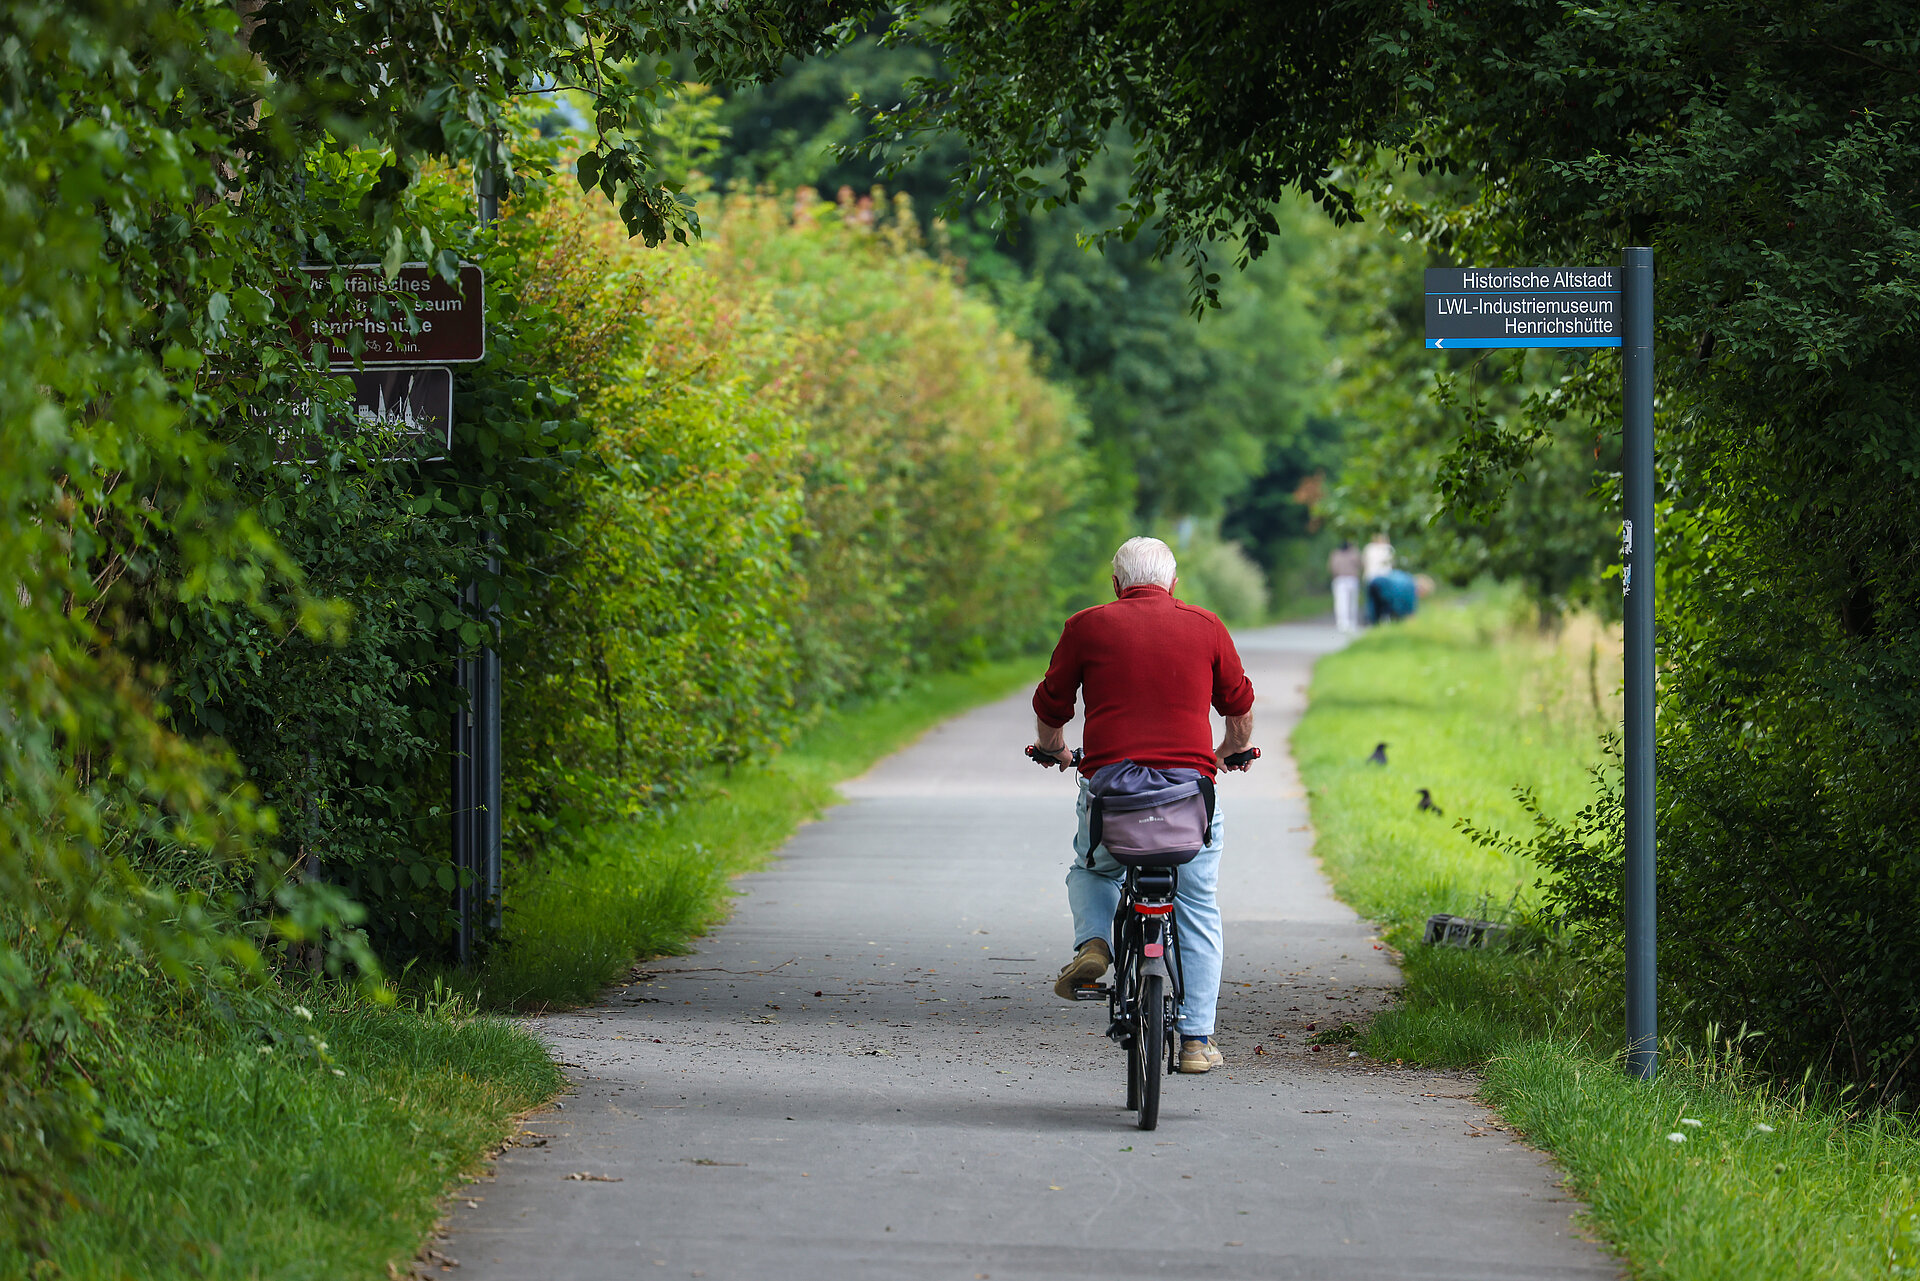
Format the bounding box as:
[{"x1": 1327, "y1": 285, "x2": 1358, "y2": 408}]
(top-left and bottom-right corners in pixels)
[{"x1": 301, "y1": 263, "x2": 486, "y2": 369}]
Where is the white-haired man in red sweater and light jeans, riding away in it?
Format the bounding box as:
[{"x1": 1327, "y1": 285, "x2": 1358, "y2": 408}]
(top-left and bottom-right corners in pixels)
[{"x1": 1029, "y1": 538, "x2": 1254, "y2": 1072}]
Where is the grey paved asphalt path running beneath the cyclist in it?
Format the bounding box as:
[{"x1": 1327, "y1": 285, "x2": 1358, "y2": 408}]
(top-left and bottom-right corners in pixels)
[{"x1": 434, "y1": 626, "x2": 1619, "y2": 1281}]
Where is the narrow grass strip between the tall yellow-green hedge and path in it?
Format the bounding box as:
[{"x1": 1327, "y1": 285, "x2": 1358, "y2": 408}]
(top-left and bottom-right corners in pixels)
[{"x1": 476, "y1": 659, "x2": 1044, "y2": 1008}]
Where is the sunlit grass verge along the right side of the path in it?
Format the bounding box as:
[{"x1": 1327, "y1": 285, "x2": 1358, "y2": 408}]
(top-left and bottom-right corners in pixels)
[{"x1": 1294, "y1": 597, "x2": 1920, "y2": 1281}]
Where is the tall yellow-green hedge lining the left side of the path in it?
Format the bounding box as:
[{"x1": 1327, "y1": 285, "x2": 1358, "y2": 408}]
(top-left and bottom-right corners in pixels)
[{"x1": 505, "y1": 194, "x2": 1089, "y2": 855}]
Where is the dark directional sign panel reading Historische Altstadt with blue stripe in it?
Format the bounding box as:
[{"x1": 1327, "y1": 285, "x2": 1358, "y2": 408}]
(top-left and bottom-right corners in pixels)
[{"x1": 1427, "y1": 267, "x2": 1622, "y2": 350}]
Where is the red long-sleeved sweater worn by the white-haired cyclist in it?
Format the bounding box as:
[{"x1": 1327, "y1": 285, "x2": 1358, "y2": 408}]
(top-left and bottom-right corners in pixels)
[{"x1": 1033, "y1": 586, "x2": 1254, "y2": 778}]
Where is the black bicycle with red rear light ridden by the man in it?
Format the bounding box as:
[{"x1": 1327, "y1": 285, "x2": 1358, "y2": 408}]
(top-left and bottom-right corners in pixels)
[{"x1": 1027, "y1": 747, "x2": 1260, "y2": 1129}]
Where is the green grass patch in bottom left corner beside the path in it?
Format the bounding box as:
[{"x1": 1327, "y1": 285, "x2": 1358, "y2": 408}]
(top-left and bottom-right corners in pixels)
[{"x1": 0, "y1": 989, "x2": 564, "y2": 1281}]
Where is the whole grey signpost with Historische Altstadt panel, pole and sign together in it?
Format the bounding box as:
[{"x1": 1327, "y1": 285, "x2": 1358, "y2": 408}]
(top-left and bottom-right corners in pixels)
[{"x1": 1427, "y1": 248, "x2": 1659, "y2": 1079}]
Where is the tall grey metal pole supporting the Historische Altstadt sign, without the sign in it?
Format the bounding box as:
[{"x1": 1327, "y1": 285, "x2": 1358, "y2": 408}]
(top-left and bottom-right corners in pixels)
[{"x1": 1620, "y1": 248, "x2": 1659, "y2": 1081}]
